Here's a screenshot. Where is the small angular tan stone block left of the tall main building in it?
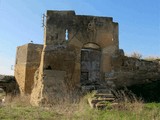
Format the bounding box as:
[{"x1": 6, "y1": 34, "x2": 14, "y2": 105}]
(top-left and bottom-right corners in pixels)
[{"x1": 15, "y1": 43, "x2": 43, "y2": 94}]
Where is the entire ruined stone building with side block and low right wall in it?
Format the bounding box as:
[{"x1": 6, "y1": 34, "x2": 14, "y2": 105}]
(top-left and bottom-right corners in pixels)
[{"x1": 15, "y1": 11, "x2": 160, "y2": 105}]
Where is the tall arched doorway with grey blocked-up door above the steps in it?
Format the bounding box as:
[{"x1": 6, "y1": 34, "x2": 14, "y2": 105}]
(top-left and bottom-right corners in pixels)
[{"x1": 80, "y1": 43, "x2": 101, "y2": 85}]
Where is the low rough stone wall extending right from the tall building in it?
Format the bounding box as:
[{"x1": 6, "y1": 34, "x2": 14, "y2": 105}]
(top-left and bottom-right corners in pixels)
[{"x1": 105, "y1": 51, "x2": 160, "y2": 88}]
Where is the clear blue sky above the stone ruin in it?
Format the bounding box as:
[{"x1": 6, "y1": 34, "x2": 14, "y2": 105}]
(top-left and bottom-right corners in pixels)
[{"x1": 0, "y1": 0, "x2": 160, "y2": 75}]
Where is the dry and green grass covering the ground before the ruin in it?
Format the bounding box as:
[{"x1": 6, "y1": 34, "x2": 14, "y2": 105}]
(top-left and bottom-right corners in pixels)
[{"x1": 0, "y1": 94, "x2": 160, "y2": 120}]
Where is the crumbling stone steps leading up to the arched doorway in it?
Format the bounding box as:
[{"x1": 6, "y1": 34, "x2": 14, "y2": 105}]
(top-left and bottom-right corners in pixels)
[{"x1": 82, "y1": 84, "x2": 118, "y2": 109}]
